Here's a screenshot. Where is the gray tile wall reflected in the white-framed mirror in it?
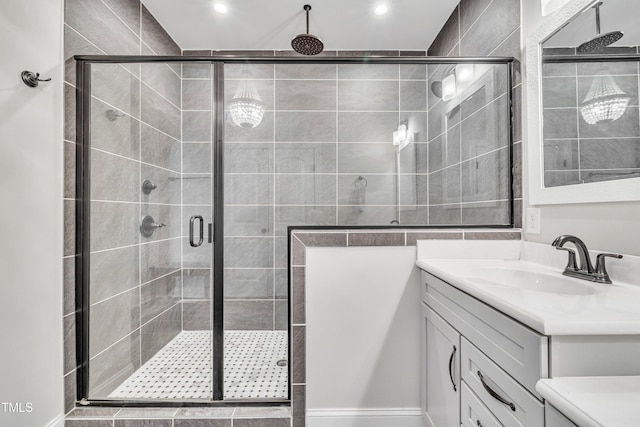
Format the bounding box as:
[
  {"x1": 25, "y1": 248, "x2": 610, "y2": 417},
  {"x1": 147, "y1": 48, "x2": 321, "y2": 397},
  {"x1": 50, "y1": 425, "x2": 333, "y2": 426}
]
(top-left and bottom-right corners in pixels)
[{"x1": 542, "y1": 48, "x2": 640, "y2": 187}]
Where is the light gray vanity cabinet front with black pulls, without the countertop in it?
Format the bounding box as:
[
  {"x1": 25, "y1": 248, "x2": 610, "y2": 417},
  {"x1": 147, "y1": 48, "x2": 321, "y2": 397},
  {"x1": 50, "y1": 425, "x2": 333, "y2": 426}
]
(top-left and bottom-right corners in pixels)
[{"x1": 422, "y1": 272, "x2": 548, "y2": 427}]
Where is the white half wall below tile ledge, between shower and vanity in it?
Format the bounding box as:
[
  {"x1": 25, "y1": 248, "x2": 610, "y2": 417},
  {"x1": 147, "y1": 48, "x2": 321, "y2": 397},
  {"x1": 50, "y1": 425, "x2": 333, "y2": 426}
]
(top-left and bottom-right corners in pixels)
[{"x1": 306, "y1": 247, "x2": 422, "y2": 427}]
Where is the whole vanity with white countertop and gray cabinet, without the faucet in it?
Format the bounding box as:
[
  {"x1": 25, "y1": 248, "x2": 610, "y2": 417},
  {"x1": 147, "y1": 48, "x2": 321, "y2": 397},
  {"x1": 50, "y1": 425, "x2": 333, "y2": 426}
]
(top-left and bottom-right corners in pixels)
[{"x1": 416, "y1": 240, "x2": 640, "y2": 427}]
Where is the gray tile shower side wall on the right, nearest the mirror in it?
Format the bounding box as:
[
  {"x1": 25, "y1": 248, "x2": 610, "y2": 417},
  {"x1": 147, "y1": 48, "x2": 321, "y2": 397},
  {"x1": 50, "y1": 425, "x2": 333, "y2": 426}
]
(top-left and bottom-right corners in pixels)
[{"x1": 427, "y1": 0, "x2": 522, "y2": 227}]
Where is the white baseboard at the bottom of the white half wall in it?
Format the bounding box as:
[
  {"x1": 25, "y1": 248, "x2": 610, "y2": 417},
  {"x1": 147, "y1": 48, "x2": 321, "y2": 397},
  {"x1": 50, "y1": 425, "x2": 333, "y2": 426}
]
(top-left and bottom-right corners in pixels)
[{"x1": 307, "y1": 408, "x2": 424, "y2": 427}]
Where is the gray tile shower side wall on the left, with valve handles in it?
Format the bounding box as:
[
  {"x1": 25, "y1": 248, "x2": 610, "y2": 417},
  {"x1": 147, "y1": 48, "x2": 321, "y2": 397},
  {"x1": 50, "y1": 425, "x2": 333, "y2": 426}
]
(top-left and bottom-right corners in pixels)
[{"x1": 63, "y1": 0, "x2": 182, "y2": 410}]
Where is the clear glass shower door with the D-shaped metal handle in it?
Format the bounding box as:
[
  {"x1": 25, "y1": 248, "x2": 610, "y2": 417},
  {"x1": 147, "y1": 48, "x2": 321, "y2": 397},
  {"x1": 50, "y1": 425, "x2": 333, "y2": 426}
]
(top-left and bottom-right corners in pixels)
[{"x1": 85, "y1": 63, "x2": 213, "y2": 400}]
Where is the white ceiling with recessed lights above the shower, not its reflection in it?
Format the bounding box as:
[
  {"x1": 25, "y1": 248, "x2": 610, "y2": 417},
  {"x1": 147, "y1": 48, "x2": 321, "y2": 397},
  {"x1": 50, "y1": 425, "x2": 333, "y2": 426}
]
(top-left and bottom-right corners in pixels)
[{"x1": 142, "y1": 0, "x2": 459, "y2": 50}]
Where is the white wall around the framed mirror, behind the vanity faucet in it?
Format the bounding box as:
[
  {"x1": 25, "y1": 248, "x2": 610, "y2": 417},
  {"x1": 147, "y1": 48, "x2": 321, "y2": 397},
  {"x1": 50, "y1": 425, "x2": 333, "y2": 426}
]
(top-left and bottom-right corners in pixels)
[{"x1": 521, "y1": 0, "x2": 640, "y2": 255}]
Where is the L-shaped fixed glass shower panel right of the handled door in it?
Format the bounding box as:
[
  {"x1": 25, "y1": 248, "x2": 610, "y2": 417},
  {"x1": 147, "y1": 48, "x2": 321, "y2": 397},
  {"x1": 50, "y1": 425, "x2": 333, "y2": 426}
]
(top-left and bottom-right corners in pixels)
[{"x1": 223, "y1": 63, "x2": 511, "y2": 399}]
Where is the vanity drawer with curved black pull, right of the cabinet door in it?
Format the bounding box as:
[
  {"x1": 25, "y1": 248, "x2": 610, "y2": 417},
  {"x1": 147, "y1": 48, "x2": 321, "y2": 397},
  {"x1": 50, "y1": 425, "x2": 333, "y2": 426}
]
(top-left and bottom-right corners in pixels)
[{"x1": 460, "y1": 337, "x2": 544, "y2": 427}]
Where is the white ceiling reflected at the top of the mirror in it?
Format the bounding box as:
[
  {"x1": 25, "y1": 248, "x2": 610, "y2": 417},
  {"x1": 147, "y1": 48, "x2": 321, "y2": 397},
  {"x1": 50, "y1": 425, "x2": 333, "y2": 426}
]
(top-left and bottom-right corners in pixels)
[{"x1": 544, "y1": 0, "x2": 640, "y2": 47}]
